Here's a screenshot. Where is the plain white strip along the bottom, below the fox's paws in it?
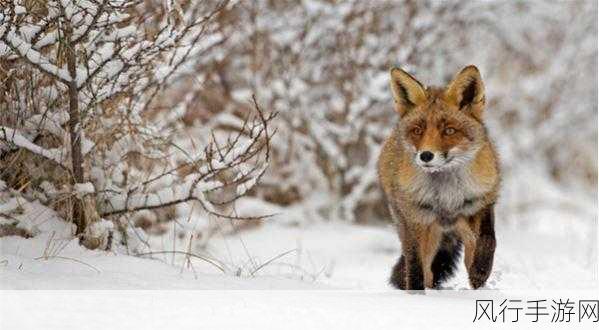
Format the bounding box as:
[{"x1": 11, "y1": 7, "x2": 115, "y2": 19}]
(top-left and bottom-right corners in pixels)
[{"x1": 5, "y1": 291, "x2": 596, "y2": 330}]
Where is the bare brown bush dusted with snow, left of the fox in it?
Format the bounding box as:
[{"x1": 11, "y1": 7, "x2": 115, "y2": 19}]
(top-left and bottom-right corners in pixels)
[{"x1": 0, "y1": 0, "x2": 274, "y2": 247}]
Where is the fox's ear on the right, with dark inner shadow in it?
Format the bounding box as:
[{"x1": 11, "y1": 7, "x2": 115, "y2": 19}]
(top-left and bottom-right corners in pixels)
[{"x1": 445, "y1": 65, "x2": 485, "y2": 116}]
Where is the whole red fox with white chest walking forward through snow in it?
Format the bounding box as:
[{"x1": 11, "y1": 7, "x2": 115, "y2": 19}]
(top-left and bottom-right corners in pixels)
[{"x1": 378, "y1": 65, "x2": 500, "y2": 291}]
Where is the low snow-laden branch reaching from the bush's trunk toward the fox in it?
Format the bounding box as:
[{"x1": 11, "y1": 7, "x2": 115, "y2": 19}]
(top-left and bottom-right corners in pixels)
[{"x1": 101, "y1": 95, "x2": 276, "y2": 219}]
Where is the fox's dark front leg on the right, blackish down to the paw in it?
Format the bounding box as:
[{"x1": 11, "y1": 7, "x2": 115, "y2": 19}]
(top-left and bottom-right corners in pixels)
[{"x1": 468, "y1": 205, "x2": 496, "y2": 289}]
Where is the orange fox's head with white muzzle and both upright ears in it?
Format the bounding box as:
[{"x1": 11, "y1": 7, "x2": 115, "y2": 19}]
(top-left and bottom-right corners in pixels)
[{"x1": 391, "y1": 65, "x2": 486, "y2": 172}]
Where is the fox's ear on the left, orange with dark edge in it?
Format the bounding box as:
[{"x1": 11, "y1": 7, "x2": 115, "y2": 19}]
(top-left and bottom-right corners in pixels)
[{"x1": 391, "y1": 68, "x2": 426, "y2": 117}]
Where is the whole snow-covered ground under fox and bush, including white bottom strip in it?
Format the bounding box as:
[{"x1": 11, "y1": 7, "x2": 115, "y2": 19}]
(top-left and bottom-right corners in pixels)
[{"x1": 0, "y1": 171, "x2": 599, "y2": 329}]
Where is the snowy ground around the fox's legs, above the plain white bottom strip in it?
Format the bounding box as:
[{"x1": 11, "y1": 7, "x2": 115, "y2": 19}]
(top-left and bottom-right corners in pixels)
[{"x1": 0, "y1": 192, "x2": 599, "y2": 292}]
